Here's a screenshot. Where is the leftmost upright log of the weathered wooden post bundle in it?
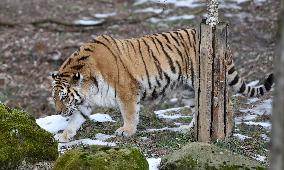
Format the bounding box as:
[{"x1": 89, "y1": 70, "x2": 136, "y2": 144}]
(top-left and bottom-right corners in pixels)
[{"x1": 195, "y1": 20, "x2": 213, "y2": 142}]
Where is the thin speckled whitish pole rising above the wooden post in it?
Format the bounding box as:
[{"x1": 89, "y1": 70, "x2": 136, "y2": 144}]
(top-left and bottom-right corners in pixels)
[{"x1": 206, "y1": 0, "x2": 219, "y2": 27}]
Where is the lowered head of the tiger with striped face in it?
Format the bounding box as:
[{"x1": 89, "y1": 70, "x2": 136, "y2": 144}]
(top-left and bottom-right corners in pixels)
[{"x1": 52, "y1": 72, "x2": 84, "y2": 116}]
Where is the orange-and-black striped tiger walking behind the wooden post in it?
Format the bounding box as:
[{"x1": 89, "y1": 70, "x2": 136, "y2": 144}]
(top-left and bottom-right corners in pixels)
[{"x1": 52, "y1": 29, "x2": 274, "y2": 141}]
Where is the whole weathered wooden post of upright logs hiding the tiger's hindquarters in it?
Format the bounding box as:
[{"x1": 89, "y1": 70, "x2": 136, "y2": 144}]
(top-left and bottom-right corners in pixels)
[{"x1": 195, "y1": 21, "x2": 233, "y2": 142}]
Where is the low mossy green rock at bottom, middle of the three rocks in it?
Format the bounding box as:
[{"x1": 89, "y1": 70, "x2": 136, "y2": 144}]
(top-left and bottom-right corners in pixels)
[{"x1": 54, "y1": 145, "x2": 149, "y2": 170}]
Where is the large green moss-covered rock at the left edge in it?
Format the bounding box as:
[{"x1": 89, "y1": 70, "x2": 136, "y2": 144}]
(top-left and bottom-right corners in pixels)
[{"x1": 0, "y1": 103, "x2": 58, "y2": 170}]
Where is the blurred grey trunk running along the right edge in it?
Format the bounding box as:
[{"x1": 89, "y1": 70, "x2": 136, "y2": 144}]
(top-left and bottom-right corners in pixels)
[{"x1": 271, "y1": 0, "x2": 284, "y2": 170}]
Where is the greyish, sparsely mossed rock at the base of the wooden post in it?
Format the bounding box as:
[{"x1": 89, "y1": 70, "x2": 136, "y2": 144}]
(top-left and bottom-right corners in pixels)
[{"x1": 160, "y1": 142, "x2": 265, "y2": 170}]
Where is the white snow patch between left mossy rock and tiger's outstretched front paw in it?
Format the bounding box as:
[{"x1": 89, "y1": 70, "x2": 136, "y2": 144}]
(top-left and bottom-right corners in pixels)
[{"x1": 36, "y1": 115, "x2": 68, "y2": 134}]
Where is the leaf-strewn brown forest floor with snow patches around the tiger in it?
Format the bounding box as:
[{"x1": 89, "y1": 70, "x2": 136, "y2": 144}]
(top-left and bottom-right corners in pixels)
[{"x1": 0, "y1": 0, "x2": 280, "y2": 169}]
